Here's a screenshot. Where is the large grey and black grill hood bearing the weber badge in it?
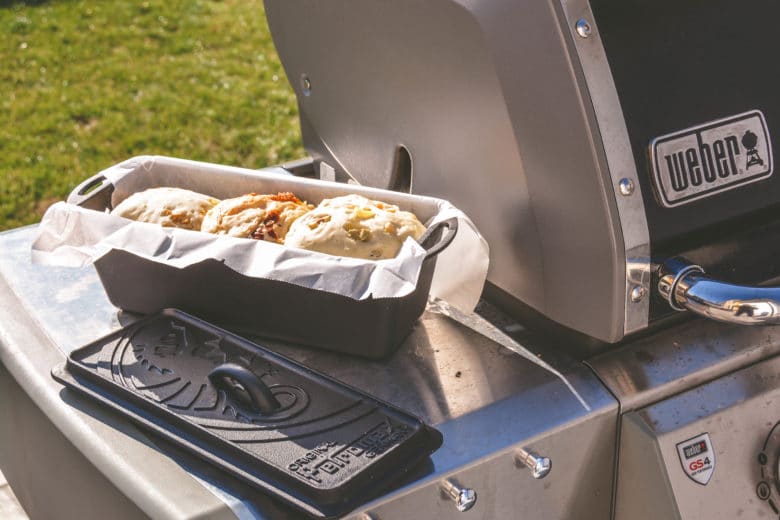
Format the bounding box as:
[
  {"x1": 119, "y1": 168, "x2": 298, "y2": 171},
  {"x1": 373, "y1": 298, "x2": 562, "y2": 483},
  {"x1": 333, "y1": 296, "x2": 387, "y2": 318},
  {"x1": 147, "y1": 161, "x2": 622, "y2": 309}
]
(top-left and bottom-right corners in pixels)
[{"x1": 264, "y1": 0, "x2": 780, "y2": 343}]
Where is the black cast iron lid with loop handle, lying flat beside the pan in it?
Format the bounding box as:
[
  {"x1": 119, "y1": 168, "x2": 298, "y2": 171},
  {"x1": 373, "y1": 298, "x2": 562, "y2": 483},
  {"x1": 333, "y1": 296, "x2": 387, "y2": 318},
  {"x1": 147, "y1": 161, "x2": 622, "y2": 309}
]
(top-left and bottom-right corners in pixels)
[{"x1": 52, "y1": 309, "x2": 442, "y2": 517}]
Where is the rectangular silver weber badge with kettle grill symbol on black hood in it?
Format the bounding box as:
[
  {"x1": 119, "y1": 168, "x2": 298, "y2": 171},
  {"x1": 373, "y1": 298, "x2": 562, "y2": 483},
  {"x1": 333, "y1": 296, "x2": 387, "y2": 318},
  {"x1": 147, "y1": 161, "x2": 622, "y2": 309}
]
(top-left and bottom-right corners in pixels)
[{"x1": 651, "y1": 110, "x2": 774, "y2": 208}]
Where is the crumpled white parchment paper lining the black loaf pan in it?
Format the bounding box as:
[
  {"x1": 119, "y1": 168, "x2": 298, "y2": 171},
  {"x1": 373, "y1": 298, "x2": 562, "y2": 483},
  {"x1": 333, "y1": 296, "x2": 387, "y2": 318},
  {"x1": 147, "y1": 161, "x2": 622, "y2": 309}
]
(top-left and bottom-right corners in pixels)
[{"x1": 32, "y1": 156, "x2": 488, "y2": 312}]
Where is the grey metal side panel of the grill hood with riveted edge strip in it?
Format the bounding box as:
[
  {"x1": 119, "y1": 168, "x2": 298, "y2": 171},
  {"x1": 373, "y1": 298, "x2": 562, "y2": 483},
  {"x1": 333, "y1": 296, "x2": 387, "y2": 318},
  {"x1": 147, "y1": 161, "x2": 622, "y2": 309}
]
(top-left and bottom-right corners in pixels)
[{"x1": 264, "y1": 0, "x2": 636, "y2": 342}]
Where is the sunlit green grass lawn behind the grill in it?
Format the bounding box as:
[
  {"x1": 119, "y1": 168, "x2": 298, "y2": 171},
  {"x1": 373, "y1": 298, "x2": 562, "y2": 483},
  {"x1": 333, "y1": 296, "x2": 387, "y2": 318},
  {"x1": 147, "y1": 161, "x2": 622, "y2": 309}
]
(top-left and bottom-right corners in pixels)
[{"x1": 0, "y1": 0, "x2": 304, "y2": 230}]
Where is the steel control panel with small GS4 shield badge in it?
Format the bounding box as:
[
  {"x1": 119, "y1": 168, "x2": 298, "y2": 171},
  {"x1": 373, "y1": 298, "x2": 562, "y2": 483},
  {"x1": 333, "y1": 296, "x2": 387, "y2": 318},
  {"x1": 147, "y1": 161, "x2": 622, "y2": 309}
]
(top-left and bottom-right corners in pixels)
[{"x1": 614, "y1": 350, "x2": 780, "y2": 520}]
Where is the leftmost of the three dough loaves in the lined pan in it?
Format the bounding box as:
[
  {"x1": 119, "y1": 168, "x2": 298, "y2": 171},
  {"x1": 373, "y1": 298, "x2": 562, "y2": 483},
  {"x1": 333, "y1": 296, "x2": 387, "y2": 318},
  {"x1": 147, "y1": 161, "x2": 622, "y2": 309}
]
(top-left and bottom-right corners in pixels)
[{"x1": 111, "y1": 188, "x2": 219, "y2": 231}]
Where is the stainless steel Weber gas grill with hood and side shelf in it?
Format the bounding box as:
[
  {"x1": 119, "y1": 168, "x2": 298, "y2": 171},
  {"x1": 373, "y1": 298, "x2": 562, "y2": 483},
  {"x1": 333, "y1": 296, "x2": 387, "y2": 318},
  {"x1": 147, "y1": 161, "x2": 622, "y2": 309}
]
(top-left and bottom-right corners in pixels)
[{"x1": 0, "y1": 0, "x2": 780, "y2": 520}]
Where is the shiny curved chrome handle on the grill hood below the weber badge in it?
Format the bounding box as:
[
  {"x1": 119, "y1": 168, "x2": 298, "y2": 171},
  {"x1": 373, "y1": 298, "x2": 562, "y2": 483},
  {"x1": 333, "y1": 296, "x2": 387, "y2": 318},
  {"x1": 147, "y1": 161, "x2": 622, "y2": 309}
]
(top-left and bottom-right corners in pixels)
[{"x1": 658, "y1": 258, "x2": 780, "y2": 325}]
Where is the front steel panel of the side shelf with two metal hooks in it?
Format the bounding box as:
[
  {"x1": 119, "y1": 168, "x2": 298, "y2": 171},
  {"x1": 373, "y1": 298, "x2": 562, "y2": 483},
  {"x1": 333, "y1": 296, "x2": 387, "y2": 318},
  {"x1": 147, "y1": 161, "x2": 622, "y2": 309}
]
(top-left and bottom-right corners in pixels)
[{"x1": 350, "y1": 406, "x2": 616, "y2": 520}]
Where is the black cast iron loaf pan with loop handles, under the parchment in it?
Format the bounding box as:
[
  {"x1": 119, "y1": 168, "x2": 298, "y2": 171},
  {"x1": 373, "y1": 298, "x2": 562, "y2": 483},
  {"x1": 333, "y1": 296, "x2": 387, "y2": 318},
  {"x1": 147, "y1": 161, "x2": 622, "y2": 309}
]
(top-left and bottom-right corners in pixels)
[{"x1": 68, "y1": 161, "x2": 458, "y2": 359}]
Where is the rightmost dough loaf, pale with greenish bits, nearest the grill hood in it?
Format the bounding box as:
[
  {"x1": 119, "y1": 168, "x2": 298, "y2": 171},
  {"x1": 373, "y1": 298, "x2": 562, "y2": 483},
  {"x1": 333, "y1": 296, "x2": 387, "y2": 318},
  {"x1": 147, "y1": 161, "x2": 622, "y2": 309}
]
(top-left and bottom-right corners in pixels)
[{"x1": 285, "y1": 195, "x2": 425, "y2": 260}]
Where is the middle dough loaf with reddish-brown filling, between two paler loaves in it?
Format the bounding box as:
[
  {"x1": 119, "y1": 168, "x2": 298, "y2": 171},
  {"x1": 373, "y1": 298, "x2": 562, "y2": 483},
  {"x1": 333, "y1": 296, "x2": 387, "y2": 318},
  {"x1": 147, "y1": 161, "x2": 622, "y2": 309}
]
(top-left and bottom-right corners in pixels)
[{"x1": 201, "y1": 193, "x2": 314, "y2": 244}]
